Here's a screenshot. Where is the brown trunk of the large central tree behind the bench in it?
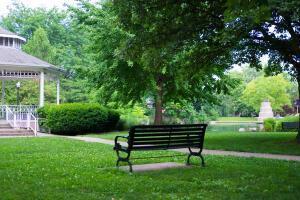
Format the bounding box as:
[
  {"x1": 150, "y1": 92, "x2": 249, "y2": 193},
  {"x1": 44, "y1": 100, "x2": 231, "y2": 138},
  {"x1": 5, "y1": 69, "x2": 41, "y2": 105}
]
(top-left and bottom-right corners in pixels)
[{"x1": 154, "y1": 76, "x2": 163, "y2": 125}]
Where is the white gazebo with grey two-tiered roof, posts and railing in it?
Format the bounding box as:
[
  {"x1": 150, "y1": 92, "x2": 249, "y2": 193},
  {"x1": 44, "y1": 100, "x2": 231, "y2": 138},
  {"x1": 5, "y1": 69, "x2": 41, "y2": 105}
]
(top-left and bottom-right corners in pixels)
[{"x1": 0, "y1": 27, "x2": 63, "y2": 134}]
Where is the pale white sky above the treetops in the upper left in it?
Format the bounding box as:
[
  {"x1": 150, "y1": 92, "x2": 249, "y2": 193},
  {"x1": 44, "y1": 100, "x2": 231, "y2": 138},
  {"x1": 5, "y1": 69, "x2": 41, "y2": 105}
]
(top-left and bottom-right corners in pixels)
[{"x1": 0, "y1": 0, "x2": 76, "y2": 16}]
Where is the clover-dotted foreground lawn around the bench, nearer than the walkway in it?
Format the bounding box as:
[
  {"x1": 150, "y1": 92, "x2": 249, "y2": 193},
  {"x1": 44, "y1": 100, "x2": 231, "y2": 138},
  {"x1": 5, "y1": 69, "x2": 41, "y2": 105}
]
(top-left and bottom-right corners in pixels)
[{"x1": 0, "y1": 137, "x2": 300, "y2": 200}]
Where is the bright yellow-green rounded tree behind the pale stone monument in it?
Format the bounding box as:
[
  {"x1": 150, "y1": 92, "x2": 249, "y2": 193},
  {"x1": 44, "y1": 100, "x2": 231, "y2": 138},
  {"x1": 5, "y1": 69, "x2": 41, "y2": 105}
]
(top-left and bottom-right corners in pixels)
[{"x1": 242, "y1": 74, "x2": 291, "y2": 111}]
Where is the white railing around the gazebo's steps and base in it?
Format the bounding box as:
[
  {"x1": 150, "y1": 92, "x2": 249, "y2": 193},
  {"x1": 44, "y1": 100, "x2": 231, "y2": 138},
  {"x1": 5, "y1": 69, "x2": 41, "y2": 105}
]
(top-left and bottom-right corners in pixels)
[{"x1": 1, "y1": 105, "x2": 38, "y2": 135}]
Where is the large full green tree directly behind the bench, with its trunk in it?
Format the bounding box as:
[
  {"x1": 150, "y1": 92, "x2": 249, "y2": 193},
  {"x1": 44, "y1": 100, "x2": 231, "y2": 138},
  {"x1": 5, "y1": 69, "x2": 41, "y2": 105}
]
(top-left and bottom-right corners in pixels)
[{"x1": 75, "y1": 0, "x2": 237, "y2": 124}]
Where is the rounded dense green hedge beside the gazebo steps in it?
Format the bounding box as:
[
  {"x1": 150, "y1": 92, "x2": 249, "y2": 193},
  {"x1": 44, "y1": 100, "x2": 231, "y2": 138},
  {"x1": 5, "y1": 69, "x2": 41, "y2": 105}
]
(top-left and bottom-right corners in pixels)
[{"x1": 38, "y1": 103, "x2": 120, "y2": 135}]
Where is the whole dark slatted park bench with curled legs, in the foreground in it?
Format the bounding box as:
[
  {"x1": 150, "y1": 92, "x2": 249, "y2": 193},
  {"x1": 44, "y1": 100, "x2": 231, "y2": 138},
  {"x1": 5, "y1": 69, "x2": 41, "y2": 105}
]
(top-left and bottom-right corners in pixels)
[{"x1": 114, "y1": 124, "x2": 207, "y2": 172}]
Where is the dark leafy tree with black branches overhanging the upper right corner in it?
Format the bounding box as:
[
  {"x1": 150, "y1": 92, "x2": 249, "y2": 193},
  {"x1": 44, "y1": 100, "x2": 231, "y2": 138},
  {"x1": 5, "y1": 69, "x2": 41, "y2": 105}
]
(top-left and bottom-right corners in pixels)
[{"x1": 227, "y1": 0, "x2": 300, "y2": 141}]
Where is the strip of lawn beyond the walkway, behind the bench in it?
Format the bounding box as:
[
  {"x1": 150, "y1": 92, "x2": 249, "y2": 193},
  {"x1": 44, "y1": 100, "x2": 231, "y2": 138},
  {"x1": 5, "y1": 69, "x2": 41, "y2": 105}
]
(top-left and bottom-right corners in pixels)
[{"x1": 88, "y1": 132, "x2": 300, "y2": 155}]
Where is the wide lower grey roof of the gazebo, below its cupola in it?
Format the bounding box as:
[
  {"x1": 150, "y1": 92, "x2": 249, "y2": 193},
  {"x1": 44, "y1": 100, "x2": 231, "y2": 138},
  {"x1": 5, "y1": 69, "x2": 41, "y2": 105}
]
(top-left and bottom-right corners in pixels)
[{"x1": 0, "y1": 46, "x2": 63, "y2": 73}]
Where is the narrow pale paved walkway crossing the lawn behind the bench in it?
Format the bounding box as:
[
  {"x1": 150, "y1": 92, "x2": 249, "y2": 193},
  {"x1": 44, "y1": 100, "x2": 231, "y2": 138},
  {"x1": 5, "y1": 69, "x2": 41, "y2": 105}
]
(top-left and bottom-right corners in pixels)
[{"x1": 67, "y1": 136, "x2": 300, "y2": 162}]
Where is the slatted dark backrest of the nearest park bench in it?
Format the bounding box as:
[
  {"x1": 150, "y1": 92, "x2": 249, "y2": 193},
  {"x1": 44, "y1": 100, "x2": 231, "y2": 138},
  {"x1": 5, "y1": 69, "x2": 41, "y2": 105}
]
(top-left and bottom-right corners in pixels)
[{"x1": 128, "y1": 124, "x2": 207, "y2": 150}]
